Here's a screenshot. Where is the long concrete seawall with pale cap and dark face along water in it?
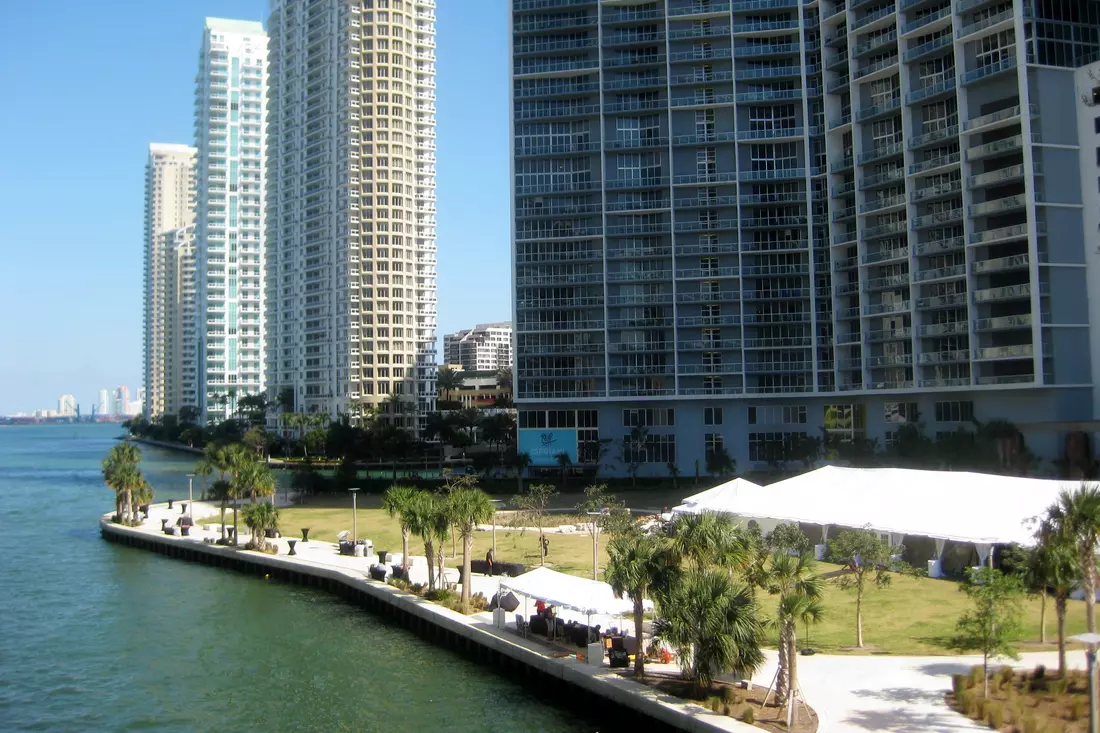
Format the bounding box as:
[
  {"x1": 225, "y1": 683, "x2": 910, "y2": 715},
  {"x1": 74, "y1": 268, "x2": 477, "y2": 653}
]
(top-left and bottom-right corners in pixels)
[{"x1": 100, "y1": 515, "x2": 759, "y2": 733}]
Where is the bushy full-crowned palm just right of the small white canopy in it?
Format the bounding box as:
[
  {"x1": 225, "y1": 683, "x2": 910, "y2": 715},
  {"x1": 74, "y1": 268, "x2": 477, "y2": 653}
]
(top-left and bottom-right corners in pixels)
[{"x1": 653, "y1": 568, "x2": 763, "y2": 697}]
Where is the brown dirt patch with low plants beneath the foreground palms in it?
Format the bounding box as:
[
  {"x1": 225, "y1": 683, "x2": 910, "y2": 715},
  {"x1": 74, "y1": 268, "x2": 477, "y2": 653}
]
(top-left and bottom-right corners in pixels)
[{"x1": 619, "y1": 671, "x2": 817, "y2": 733}]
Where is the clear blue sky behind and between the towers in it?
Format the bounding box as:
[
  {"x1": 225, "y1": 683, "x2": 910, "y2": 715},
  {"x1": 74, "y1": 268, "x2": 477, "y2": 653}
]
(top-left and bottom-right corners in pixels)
[{"x1": 0, "y1": 0, "x2": 510, "y2": 415}]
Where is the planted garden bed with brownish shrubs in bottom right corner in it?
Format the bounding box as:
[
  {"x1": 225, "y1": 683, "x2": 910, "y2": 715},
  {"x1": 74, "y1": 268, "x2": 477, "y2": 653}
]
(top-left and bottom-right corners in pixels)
[{"x1": 947, "y1": 665, "x2": 1089, "y2": 733}]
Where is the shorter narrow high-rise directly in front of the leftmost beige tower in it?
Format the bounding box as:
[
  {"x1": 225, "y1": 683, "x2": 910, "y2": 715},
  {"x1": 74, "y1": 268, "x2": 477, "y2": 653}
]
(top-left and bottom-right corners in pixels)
[{"x1": 161, "y1": 227, "x2": 200, "y2": 415}]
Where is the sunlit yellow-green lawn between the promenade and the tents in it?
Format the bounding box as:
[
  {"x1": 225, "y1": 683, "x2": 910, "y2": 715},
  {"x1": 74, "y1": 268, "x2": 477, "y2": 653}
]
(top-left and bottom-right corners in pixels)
[{"x1": 236, "y1": 495, "x2": 1085, "y2": 655}]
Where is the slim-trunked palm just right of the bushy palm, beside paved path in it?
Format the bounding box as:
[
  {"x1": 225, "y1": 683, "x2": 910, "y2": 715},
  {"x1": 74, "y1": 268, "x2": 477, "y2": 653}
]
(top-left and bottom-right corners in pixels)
[{"x1": 761, "y1": 553, "x2": 825, "y2": 704}]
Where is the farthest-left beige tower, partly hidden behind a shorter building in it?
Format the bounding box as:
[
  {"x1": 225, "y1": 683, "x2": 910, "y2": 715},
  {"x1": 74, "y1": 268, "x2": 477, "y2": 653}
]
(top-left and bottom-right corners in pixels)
[{"x1": 143, "y1": 143, "x2": 195, "y2": 415}]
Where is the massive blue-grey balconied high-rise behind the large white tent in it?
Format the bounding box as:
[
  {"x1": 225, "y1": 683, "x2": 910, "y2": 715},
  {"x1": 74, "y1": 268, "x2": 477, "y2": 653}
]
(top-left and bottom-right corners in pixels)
[{"x1": 510, "y1": 0, "x2": 1100, "y2": 471}]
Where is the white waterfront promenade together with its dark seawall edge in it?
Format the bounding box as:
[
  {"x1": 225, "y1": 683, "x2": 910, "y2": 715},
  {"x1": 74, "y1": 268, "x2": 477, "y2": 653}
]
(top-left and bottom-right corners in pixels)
[{"x1": 100, "y1": 502, "x2": 756, "y2": 733}]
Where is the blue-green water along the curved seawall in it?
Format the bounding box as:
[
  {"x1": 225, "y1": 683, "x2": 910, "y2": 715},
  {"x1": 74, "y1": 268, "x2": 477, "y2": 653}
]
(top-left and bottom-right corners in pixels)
[{"x1": 0, "y1": 425, "x2": 595, "y2": 733}]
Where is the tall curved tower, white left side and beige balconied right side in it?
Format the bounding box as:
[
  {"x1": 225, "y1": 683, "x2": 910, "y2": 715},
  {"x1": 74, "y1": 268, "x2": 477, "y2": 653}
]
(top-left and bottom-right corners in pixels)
[{"x1": 266, "y1": 0, "x2": 436, "y2": 430}]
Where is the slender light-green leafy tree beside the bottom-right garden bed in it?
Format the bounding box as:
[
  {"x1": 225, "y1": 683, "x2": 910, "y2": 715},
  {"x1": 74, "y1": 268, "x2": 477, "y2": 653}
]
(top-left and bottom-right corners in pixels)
[{"x1": 949, "y1": 568, "x2": 1024, "y2": 697}]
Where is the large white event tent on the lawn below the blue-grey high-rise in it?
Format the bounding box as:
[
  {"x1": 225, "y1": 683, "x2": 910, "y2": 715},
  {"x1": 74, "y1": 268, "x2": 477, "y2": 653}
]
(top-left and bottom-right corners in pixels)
[{"x1": 673, "y1": 466, "x2": 1080, "y2": 572}]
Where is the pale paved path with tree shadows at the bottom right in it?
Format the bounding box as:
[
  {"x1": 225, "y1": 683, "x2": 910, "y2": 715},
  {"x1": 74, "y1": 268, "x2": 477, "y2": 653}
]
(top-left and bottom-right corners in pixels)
[{"x1": 754, "y1": 650, "x2": 1086, "y2": 733}]
